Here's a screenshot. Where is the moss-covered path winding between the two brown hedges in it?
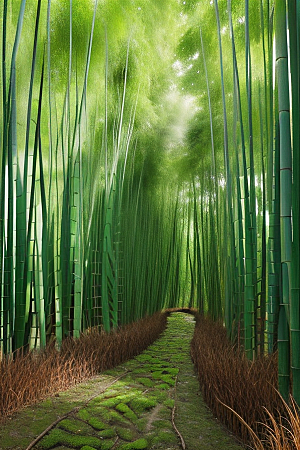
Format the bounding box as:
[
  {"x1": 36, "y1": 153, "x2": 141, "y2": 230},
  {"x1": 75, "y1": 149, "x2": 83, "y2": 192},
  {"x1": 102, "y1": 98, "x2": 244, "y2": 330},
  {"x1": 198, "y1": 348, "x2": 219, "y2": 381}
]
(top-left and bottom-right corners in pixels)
[{"x1": 0, "y1": 313, "x2": 243, "y2": 450}]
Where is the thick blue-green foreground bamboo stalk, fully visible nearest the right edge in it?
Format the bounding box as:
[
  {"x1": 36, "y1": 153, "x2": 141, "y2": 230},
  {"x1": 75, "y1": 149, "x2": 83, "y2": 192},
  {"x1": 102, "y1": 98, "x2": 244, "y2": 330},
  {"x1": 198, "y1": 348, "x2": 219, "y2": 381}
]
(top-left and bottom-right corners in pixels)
[{"x1": 275, "y1": 0, "x2": 292, "y2": 400}]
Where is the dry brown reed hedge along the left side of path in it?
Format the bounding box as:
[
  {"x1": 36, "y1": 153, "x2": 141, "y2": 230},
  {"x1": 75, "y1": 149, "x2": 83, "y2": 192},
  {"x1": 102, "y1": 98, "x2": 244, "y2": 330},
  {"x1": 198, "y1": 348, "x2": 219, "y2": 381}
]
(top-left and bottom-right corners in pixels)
[{"x1": 0, "y1": 312, "x2": 168, "y2": 420}]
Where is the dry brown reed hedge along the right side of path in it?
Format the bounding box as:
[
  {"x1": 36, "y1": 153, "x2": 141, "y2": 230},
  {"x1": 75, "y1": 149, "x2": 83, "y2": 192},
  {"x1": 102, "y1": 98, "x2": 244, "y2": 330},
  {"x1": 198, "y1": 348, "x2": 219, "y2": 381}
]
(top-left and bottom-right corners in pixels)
[{"x1": 191, "y1": 314, "x2": 283, "y2": 442}]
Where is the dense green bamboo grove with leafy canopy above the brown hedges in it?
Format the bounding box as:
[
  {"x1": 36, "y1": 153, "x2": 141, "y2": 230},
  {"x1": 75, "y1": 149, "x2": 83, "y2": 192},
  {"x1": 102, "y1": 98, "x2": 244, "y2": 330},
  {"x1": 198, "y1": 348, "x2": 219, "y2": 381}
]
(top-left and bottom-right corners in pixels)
[{"x1": 0, "y1": 0, "x2": 300, "y2": 403}]
